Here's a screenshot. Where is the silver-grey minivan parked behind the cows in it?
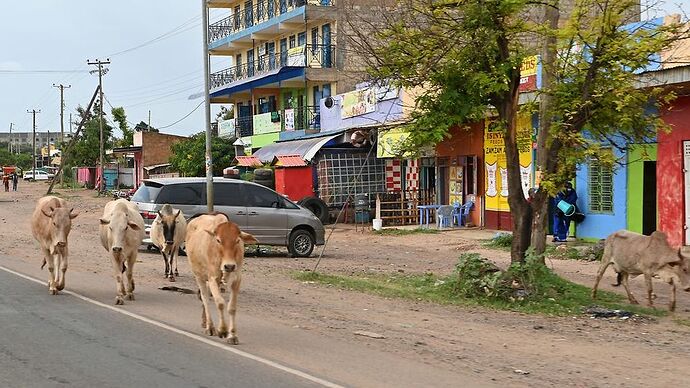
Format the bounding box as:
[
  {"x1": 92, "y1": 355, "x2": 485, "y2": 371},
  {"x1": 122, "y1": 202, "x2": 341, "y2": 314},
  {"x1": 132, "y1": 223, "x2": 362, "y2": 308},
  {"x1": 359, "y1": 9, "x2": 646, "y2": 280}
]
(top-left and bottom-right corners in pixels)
[{"x1": 131, "y1": 178, "x2": 325, "y2": 257}]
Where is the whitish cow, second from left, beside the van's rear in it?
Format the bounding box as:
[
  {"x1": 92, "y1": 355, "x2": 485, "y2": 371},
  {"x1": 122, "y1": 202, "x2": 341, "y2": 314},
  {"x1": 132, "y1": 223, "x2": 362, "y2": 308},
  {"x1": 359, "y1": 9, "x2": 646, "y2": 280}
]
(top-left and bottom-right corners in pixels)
[{"x1": 100, "y1": 198, "x2": 144, "y2": 305}]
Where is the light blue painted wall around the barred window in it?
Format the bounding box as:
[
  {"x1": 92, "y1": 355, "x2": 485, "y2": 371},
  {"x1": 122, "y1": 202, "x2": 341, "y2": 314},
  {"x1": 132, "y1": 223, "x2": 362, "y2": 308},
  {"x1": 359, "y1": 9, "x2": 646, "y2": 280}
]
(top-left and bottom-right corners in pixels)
[{"x1": 575, "y1": 148, "x2": 628, "y2": 240}]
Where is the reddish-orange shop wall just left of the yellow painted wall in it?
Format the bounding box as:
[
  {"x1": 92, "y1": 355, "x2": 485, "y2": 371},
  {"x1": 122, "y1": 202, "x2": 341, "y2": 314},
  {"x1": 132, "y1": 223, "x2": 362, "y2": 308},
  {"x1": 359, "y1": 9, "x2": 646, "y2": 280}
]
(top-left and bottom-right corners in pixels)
[{"x1": 436, "y1": 122, "x2": 484, "y2": 225}]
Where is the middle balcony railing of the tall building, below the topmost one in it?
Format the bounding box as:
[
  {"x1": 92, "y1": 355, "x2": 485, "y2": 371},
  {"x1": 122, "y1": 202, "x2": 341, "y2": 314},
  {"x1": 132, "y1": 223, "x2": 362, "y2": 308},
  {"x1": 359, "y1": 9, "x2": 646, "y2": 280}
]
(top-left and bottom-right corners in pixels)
[{"x1": 210, "y1": 45, "x2": 336, "y2": 89}]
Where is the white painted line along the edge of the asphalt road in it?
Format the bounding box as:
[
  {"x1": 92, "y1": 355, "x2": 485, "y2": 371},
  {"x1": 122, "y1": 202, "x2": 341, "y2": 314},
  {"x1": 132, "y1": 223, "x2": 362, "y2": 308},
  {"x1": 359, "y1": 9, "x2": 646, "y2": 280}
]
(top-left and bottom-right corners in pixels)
[{"x1": 0, "y1": 265, "x2": 344, "y2": 388}]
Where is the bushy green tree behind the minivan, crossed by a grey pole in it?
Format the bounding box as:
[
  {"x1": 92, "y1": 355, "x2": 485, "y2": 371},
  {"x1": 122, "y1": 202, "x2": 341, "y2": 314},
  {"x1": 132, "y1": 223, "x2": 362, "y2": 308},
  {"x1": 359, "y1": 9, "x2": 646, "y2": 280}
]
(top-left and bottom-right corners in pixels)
[{"x1": 170, "y1": 132, "x2": 235, "y2": 176}]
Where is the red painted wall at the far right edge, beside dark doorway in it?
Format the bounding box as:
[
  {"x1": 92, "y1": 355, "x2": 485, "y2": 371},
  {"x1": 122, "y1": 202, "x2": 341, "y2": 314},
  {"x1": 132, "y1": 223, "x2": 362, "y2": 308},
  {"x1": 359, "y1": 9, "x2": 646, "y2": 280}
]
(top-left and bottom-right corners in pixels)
[{"x1": 656, "y1": 96, "x2": 690, "y2": 246}]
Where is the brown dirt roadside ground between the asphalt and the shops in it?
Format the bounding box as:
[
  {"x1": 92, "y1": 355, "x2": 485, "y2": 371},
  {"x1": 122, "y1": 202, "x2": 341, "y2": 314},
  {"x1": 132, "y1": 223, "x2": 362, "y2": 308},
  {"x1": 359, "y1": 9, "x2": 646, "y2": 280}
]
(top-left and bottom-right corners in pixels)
[{"x1": 0, "y1": 183, "x2": 690, "y2": 387}]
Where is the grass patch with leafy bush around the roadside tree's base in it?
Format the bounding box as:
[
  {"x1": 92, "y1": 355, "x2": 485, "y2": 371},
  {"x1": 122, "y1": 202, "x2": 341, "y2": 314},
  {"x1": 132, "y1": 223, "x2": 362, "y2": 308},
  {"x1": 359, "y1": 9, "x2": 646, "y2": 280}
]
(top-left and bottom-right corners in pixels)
[{"x1": 293, "y1": 254, "x2": 667, "y2": 316}]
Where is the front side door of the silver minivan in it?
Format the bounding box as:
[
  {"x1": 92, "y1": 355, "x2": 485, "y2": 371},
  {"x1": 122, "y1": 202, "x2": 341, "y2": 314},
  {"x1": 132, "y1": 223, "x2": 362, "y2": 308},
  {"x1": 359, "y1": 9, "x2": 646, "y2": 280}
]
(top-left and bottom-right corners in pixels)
[{"x1": 242, "y1": 184, "x2": 288, "y2": 245}]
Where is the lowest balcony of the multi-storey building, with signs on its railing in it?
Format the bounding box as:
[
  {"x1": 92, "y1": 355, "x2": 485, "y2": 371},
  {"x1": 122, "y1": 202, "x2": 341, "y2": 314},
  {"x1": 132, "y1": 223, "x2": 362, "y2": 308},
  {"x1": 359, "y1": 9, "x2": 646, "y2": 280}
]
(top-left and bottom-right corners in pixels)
[{"x1": 235, "y1": 106, "x2": 321, "y2": 137}]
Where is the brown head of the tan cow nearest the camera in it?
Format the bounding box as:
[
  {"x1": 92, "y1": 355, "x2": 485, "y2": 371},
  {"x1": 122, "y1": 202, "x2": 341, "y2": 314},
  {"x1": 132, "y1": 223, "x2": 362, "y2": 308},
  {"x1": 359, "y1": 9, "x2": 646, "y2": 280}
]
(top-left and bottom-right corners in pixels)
[{"x1": 206, "y1": 221, "x2": 258, "y2": 277}]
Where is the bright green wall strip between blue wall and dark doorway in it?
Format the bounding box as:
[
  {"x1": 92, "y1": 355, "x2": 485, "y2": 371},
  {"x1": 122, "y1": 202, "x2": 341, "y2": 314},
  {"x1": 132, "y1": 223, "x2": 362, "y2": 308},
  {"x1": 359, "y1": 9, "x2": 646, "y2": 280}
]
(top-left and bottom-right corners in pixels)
[{"x1": 627, "y1": 144, "x2": 657, "y2": 233}]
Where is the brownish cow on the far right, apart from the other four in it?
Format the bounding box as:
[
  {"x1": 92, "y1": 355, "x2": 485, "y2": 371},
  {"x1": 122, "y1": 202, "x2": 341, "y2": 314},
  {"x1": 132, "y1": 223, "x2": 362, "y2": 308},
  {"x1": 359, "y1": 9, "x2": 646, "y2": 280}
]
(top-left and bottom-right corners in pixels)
[{"x1": 592, "y1": 230, "x2": 690, "y2": 311}]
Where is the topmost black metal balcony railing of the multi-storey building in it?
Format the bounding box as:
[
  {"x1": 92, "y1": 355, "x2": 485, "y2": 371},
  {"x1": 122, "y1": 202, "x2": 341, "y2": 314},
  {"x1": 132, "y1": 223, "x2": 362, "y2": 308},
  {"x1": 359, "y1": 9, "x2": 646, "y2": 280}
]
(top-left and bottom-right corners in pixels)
[{"x1": 208, "y1": 0, "x2": 335, "y2": 43}]
